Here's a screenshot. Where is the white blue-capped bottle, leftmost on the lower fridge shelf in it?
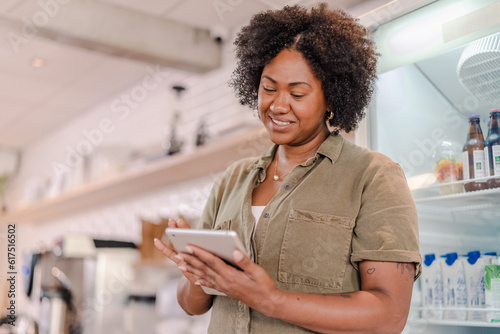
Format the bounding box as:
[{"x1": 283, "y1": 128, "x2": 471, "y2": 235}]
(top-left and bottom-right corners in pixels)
[{"x1": 420, "y1": 254, "x2": 443, "y2": 320}]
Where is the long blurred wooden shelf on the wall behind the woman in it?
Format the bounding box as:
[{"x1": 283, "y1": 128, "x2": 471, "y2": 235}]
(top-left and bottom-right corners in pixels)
[{"x1": 0, "y1": 128, "x2": 271, "y2": 223}]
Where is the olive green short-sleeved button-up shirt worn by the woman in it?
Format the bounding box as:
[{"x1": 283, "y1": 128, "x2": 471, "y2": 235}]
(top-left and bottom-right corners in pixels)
[{"x1": 201, "y1": 134, "x2": 421, "y2": 334}]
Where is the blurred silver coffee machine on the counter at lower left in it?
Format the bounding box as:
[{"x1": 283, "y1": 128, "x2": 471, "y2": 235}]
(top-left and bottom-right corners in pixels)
[{"x1": 23, "y1": 235, "x2": 140, "y2": 334}]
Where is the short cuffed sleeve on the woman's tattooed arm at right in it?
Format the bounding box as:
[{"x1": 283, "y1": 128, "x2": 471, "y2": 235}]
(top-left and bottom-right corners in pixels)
[{"x1": 351, "y1": 162, "x2": 421, "y2": 279}]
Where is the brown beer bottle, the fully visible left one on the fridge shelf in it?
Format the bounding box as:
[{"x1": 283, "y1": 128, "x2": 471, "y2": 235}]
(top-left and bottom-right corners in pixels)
[{"x1": 462, "y1": 115, "x2": 488, "y2": 191}]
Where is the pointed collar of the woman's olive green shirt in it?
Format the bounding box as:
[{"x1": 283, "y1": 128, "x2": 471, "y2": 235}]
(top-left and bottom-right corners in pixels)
[{"x1": 248, "y1": 132, "x2": 344, "y2": 171}]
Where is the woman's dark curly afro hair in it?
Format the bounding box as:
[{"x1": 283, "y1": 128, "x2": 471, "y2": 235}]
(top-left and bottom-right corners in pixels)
[{"x1": 230, "y1": 3, "x2": 378, "y2": 132}]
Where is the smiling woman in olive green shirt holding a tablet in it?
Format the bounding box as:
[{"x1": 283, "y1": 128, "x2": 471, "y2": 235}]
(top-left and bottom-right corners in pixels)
[{"x1": 155, "y1": 4, "x2": 421, "y2": 334}]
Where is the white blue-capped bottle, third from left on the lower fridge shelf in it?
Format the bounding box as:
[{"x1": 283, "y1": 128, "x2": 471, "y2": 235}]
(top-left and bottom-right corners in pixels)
[{"x1": 462, "y1": 251, "x2": 486, "y2": 321}]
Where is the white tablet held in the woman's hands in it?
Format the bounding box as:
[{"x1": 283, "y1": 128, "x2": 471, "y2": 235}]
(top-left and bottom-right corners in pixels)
[{"x1": 165, "y1": 228, "x2": 248, "y2": 296}]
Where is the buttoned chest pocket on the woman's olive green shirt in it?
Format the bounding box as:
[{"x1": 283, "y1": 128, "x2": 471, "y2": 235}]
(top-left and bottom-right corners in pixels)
[{"x1": 278, "y1": 210, "x2": 354, "y2": 292}]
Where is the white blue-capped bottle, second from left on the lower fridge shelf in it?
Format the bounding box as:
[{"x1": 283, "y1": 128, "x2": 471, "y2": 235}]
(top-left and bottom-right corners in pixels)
[{"x1": 440, "y1": 253, "x2": 467, "y2": 321}]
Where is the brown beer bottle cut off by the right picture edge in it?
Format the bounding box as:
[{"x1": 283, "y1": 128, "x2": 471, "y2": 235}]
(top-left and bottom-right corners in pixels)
[{"x1": 484, "y1": 109, "x2": 500, "y2": 189}]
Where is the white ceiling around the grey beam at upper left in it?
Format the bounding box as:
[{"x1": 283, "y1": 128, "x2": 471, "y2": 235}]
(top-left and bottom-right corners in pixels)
[{"x1": 0, "y1": 0, "x2": 389, "y2": 149}]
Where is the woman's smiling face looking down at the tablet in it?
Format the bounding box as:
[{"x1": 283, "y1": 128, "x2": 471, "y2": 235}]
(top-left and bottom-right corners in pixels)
[{"x1": 258, "y1": 49, "x2": 329, "y2": 146}]
